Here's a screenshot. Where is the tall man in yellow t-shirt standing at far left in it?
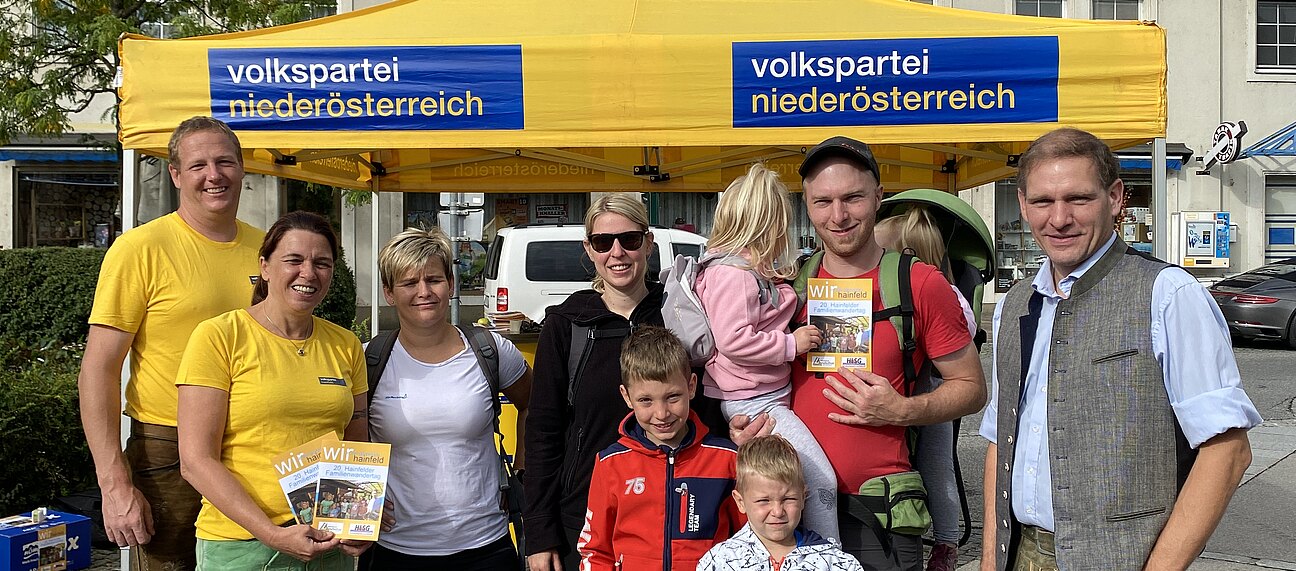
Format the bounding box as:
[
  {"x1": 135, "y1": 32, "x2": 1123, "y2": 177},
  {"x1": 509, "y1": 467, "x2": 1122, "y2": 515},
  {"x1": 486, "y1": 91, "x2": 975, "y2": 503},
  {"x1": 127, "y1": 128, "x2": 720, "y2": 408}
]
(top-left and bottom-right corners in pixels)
[{"x1": 78, "y1": 117, "x2": 264, "y2": 571}]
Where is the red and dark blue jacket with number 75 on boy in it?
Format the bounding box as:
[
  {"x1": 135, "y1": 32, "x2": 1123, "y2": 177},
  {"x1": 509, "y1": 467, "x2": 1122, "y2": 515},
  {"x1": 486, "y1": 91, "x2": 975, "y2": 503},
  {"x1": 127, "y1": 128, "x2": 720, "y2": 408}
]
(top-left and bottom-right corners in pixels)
[{"x1": 577, "y1": 412, "x2": 746, "y2": 571}]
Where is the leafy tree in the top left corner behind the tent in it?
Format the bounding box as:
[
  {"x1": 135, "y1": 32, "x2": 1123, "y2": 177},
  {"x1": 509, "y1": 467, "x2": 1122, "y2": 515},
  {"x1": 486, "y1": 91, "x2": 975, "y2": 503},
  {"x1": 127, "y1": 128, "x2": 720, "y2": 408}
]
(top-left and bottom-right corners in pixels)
[{"x1": 0, "y1": 0, "x2": 336, "y2": 145}]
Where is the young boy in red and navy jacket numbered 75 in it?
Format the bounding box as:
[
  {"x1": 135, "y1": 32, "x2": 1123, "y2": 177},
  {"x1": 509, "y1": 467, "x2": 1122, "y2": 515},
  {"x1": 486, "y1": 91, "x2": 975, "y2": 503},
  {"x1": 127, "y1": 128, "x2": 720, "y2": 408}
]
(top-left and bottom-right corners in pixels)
[{"x1": 577, "y1": 326, "x2": 746, "y2": 571}]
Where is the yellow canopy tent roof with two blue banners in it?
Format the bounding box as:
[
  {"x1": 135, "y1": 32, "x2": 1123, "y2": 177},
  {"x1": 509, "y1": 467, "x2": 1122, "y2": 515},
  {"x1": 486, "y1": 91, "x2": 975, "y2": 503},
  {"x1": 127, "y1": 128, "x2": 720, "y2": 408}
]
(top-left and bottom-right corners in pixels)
[{"x1": 121, "y1": 0, "x2": 1166, "y2": 192}]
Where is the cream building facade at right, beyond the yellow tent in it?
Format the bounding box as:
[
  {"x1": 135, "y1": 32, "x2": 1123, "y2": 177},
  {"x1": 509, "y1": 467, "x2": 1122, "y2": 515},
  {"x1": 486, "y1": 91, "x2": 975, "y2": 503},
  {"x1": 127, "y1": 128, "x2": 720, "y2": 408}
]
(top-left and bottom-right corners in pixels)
[{"x1": 943, "y1": 0, "x2": 1296, "y2": 300}]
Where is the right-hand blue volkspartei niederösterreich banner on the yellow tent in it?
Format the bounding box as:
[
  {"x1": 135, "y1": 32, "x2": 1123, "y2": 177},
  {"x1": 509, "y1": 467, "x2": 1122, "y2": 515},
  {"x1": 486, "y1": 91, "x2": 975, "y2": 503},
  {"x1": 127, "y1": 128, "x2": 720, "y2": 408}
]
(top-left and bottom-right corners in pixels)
[{"x1": 732, "y1": 36, "x2": 1058, "y2": 127}]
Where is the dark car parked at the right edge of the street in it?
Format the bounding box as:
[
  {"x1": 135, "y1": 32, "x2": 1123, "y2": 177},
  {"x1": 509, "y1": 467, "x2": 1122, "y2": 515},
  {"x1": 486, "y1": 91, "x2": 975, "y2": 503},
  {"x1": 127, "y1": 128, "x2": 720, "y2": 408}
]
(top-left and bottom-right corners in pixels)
[{"x1": 1210, "y1": 258, "x2": 1296, "y2": 348}]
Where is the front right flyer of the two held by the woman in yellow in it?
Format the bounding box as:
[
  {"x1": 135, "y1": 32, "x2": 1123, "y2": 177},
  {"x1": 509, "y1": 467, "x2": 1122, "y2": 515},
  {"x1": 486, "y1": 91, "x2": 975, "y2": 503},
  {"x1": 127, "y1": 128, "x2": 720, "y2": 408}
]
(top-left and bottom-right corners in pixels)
[{"x1": 314, "y1": 440, "x2": 391, "y2": 541}]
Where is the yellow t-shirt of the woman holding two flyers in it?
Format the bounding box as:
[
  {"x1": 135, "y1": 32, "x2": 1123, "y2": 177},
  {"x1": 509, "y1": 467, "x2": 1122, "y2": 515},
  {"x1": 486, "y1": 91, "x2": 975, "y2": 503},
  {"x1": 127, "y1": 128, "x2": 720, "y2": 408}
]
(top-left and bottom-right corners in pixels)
[{"x1": 175, "y1": 309, "x2": 369, "y2": 540}]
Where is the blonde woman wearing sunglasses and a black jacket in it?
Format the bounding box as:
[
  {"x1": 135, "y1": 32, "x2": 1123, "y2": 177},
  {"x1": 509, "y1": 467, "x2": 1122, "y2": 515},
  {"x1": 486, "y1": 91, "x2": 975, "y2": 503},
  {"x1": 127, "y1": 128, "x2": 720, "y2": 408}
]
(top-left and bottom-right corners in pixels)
[{"x1": 522, "y1": 194, "x2": 727, "y2": 571}]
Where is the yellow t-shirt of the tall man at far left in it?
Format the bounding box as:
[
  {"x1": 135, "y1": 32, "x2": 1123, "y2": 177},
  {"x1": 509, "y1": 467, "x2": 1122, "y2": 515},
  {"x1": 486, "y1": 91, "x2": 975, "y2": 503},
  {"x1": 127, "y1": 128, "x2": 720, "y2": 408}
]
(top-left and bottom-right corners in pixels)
[{"x1": 89, "y1": 212, "x2": 266, "y2": 426}]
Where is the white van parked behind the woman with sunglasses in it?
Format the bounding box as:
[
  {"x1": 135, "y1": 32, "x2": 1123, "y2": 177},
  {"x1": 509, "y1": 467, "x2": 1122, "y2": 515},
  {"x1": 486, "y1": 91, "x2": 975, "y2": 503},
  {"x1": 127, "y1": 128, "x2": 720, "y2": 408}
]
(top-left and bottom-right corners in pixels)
[{"x1": 483, "y1": 223, "x2": 706, "y2": 322}]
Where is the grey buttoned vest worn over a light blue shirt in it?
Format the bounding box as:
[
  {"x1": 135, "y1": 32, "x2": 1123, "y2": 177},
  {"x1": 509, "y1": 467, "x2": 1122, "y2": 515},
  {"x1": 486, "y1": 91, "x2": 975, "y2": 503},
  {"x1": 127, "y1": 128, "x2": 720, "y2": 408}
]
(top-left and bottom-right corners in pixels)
[{"x1": 988, "y1": 238, "x2": 1186, "y2": 570}]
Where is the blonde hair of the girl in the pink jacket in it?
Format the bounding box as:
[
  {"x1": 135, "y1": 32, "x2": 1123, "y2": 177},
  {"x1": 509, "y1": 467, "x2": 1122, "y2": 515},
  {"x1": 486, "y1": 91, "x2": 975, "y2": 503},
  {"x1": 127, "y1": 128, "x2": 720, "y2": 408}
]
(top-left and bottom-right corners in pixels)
[{"x1": 706, "y1": 163, "x2": 796, "y2": 280}]
